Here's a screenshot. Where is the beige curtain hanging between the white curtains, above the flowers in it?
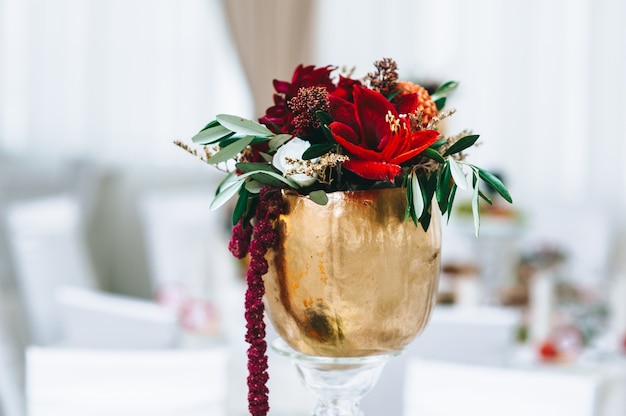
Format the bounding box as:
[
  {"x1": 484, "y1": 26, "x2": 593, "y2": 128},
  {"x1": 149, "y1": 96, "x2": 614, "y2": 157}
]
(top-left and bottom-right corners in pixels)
[{"x1": 221, "y1": 0, "x2": 315, "y2": 117}]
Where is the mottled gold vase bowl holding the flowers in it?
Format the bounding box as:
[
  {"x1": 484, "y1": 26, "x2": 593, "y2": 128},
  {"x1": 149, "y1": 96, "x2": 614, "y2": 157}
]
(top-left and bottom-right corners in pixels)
[{"x1": 265, "y1": 188, "x2": 441, "y2": 357}]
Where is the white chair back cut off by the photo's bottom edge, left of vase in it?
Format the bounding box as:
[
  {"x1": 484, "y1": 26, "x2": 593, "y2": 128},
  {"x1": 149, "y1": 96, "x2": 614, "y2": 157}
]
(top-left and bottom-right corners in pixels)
[{"x1": 26, "y1": 347, "x2": 229, "y2": 416}]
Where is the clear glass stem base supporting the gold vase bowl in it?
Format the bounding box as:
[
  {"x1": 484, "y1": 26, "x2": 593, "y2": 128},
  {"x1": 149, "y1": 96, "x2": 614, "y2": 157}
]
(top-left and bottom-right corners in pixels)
[{"x1": 272, "y1": 338, "x2": 400, "y2": 416}]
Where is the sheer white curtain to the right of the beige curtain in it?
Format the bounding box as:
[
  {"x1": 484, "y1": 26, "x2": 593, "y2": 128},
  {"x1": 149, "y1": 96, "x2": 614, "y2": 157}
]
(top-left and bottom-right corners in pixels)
[{"x1": 316, "y1": 0, "x2": 626, "y2": 228}]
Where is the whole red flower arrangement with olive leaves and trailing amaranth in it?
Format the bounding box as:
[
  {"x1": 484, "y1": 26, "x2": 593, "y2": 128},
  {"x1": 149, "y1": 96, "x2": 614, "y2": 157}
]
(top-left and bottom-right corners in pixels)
[{"x1": 176, "y1": 58, "x2": 512, "y2": 415}]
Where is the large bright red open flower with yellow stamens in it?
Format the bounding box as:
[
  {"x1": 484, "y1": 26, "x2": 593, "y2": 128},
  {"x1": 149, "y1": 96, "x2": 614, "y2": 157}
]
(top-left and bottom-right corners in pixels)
[{"x1": 329, "y1": 85, "x2": 439, "y2": 181}]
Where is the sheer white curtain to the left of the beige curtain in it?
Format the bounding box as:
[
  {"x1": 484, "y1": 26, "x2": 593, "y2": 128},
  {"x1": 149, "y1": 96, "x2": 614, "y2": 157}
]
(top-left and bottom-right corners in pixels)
[{"x1": 0, "y1": 0, "x2": 252, "y2": 165}]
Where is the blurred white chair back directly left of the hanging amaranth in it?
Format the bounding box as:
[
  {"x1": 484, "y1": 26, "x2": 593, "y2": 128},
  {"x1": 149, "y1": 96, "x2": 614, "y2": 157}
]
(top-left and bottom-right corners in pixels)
[{"x1": 138, "y1": 188, "x2": 236, "y2": 299}]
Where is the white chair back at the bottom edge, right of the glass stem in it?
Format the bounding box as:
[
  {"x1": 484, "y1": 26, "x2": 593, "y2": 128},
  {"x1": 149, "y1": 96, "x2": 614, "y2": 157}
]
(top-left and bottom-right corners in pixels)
[{"x1": 404, "y1": 359, "x2": 598, "y2": 416}]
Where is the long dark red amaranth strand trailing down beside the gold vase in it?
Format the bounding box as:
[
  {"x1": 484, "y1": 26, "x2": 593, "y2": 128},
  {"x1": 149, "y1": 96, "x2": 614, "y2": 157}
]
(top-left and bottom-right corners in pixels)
[{"x1": 229, "y1": 187, "x2": 284, "y2": 416}]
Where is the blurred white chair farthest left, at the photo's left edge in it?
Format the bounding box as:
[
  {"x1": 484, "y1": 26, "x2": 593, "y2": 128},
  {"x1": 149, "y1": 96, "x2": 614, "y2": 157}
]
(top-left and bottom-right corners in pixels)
[{"x1": 6, "y1": 194, "x2": 98, "y2": 345}]
